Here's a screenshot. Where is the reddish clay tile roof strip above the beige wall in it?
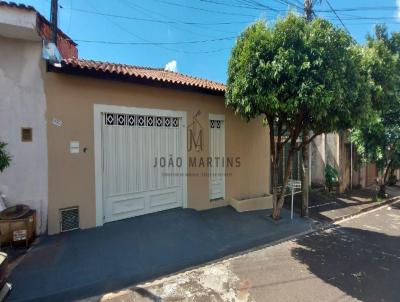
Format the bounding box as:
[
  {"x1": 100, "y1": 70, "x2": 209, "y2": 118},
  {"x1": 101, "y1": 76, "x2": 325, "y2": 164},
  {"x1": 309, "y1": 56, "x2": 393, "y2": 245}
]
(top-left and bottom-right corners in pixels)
[{"x1": 62, "y1": 58, "x2": 225, "y2": 93}]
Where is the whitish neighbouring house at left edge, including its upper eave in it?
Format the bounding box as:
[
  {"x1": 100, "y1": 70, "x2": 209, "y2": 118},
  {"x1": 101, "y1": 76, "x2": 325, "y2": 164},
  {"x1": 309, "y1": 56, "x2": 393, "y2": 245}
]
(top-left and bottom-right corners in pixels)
[{"x1": 0, "y1": 1, "x2": 77, "y2": 232}]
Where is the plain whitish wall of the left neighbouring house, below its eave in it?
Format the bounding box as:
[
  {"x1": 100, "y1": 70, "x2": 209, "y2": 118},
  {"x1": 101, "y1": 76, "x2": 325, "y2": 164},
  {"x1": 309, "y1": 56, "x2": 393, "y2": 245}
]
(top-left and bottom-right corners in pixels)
[{"x1": 0, "y1": 36, "x2": 48, "y2": 232}]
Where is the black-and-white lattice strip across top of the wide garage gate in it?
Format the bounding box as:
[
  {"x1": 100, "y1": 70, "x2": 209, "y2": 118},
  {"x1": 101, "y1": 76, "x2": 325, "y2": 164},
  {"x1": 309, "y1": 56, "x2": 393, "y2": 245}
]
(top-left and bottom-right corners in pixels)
[{"x1": 104, "y1": 113, "x2": 180, "y2": 128}]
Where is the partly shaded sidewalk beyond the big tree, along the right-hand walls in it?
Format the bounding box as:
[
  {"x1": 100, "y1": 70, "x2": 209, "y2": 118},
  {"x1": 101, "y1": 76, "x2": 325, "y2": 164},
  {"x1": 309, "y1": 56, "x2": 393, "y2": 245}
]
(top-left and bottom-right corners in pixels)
[{"x1": 285, "y1": 185, "x2": 400, "y2": 223}]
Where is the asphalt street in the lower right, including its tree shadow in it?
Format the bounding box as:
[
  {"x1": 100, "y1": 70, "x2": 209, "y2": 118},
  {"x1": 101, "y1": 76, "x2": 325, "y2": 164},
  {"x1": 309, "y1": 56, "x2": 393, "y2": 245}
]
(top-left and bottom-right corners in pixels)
[{"x1": 92, "y1": 203, "x2": 400, "y2": 302}]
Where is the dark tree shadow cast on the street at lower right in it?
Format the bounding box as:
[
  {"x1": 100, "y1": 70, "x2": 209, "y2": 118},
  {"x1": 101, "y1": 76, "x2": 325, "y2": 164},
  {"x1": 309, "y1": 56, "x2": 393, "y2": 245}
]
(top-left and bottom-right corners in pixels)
[{"x1": 291, "y1": 204, "x2": 400, "y2": 302}]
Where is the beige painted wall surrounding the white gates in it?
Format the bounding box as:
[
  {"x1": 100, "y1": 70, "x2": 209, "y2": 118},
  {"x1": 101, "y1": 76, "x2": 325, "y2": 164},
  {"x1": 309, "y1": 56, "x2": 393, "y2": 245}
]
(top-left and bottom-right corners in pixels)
[{"x1": 44, "y1": 73, "x2": 270, "y2": 234}]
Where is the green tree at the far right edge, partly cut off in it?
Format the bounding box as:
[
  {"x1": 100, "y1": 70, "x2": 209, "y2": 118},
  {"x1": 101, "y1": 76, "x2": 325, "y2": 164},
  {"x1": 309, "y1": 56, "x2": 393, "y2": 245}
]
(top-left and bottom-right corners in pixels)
[{"x1": 352, "y1": 25, "x2": 400, "y2": 195}]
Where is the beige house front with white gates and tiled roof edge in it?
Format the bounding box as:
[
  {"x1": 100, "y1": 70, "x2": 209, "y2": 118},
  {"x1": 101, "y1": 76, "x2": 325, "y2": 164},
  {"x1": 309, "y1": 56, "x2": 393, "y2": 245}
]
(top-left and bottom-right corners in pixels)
[{"x1": 44, "y1": 59, "x2": 269, "y2": 233}]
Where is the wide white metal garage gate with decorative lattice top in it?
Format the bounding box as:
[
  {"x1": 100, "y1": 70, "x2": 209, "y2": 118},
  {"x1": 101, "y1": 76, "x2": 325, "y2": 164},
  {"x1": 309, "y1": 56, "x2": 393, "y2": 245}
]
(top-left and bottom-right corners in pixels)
[{"x1": 101, "y1": 110, "x2": 186, "y2": 222}]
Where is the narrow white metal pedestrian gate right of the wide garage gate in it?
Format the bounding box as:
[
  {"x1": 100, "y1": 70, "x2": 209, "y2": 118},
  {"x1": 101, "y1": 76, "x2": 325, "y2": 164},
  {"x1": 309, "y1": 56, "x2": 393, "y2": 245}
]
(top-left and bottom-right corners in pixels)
[{"x1": 209, "y1": 114, "x2": 225, "y2": 200}]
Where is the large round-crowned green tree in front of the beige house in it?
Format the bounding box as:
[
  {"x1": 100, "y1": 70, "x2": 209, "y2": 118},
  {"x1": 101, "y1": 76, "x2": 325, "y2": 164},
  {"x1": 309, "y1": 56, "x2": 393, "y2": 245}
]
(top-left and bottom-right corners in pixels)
[{"x1": 226, "y1": 14, "x2": 369, "y2": 219}]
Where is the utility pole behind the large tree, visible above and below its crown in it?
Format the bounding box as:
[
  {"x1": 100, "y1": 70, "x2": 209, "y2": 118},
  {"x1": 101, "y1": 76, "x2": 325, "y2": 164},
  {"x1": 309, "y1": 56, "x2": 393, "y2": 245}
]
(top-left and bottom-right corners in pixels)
[{"x1": 301, "y1": 0, "x2": 313, "y2": 217}]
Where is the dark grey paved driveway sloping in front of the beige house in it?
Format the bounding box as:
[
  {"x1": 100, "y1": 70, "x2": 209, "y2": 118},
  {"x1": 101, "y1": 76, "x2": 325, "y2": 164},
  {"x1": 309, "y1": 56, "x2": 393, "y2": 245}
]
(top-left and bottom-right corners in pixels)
[{"x1": 10, "y1": 207, "x2": 311, "y2": 301}]
